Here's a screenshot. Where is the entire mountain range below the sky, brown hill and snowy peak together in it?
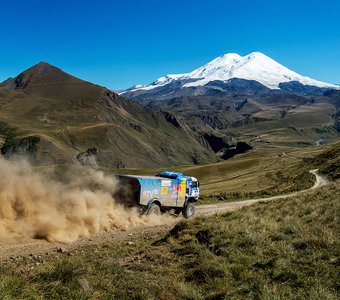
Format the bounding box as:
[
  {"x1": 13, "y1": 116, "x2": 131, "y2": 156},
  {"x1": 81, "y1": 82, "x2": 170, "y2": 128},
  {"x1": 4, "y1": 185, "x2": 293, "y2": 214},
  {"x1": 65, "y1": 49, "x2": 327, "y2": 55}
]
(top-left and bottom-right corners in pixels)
[{"x1": 0, "y1": 53, "x2": 340, "y2": 168}]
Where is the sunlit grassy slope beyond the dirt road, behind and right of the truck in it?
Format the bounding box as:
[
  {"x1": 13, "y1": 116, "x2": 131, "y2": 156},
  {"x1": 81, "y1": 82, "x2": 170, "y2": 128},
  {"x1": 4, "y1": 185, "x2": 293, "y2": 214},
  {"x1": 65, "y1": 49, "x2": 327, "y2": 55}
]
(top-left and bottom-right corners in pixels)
[{"x1": 113, "y1": 144, "x2": 340, "y2": 203}]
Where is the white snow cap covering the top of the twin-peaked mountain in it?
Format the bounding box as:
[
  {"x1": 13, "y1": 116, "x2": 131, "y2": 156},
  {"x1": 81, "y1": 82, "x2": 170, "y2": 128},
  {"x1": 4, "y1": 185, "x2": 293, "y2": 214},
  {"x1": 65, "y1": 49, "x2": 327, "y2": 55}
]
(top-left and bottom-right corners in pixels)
[{"x1": 122, "y1": 52, "x2": 340, "y2": 94}]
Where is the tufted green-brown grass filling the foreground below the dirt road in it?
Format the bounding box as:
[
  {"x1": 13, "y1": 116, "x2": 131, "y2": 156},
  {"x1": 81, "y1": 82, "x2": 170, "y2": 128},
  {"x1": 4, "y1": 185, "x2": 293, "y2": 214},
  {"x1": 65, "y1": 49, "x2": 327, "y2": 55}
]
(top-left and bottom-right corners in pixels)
[{"x1": 0, "y1": 182, "x2": 340, "y2": 299}]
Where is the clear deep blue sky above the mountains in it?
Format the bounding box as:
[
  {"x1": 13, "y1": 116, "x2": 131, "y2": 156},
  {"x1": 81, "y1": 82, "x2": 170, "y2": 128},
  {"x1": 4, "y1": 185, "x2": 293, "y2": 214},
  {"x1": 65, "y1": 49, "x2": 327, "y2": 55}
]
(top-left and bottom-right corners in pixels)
[{"x1": 0, "y1": 0, "x2": 340, "y2": 89}]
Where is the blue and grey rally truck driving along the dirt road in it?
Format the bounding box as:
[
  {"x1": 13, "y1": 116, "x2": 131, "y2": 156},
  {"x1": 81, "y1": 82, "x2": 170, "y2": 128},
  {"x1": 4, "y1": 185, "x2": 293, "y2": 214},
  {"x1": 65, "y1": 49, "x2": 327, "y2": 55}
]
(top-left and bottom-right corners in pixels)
[{"x1": 114, "y1": 171, "x2": 200, "y2": 218}]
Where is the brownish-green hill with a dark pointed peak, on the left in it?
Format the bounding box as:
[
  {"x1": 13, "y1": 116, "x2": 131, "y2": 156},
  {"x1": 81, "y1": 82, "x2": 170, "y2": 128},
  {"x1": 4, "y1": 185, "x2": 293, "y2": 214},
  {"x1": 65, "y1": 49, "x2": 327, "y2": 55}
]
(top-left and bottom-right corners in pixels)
[{"x1": 0, "y1": 62, "x2": 217, "y2": 168}]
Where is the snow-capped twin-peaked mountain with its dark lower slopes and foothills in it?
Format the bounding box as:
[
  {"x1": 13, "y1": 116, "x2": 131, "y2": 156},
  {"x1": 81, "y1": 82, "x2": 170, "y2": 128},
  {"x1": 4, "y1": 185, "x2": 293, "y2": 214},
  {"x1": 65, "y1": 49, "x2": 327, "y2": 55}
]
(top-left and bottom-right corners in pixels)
[{"x1": 120, "y1": 52, "x2": 340, "y2": 146}]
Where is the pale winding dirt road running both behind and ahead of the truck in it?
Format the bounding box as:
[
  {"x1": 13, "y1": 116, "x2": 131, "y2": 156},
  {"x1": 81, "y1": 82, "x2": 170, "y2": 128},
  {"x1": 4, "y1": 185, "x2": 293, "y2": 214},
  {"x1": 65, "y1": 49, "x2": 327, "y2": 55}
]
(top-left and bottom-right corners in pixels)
[{"x1": 0, "y1": 170, "x2": 328, "y2": 261}]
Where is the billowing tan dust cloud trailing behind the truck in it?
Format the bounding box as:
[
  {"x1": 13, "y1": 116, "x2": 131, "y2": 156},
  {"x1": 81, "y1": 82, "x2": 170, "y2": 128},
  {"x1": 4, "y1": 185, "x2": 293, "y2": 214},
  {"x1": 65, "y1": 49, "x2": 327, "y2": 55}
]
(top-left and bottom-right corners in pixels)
[{"x1": 0, "y1": 157, "x2": 173, "y2": 243}]
